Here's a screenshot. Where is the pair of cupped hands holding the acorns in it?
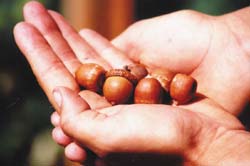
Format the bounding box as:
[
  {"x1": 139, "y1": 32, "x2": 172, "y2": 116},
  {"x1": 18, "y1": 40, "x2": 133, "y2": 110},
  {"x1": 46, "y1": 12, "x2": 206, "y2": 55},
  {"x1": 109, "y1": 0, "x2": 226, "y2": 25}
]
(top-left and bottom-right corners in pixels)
[{"x1": 14, "y1": 2, "x2": 250, "y2": 165}]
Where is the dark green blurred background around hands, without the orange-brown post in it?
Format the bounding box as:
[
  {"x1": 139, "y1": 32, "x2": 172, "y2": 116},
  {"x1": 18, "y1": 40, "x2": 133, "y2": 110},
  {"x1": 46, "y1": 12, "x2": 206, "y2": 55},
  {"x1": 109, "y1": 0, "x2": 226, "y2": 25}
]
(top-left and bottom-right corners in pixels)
[{"x1": 0, "y1": 0, "x2": 249, "y2": 166}]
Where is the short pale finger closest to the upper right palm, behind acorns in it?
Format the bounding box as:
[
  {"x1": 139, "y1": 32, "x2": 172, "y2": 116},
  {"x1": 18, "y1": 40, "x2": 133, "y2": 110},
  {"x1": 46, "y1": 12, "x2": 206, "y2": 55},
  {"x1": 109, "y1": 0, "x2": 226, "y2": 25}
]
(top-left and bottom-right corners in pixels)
[{"x1": 79, "y1": 29, "x2": 133, "y2": 68}]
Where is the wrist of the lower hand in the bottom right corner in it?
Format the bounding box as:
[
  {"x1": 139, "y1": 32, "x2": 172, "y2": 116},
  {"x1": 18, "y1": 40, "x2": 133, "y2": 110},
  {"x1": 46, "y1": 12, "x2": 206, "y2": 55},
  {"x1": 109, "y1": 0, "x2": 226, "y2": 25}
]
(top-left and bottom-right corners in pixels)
[{"x1": 195, "y1": 130, "x2": 250, "y2": 165}]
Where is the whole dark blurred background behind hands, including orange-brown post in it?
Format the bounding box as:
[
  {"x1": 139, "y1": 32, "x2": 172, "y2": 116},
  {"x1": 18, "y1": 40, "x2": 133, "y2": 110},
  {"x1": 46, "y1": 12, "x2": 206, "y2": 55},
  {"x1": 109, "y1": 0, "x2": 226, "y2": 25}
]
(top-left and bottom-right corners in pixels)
[{"x1": 0, "y1": 0, "x2": 250, "y2": 166}]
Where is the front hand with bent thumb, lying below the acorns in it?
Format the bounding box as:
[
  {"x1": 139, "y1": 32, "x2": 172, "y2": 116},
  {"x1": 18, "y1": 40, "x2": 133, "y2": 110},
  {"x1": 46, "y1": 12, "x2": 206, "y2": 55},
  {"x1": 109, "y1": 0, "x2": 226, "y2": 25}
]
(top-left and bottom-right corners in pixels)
[{"x1": 54, "y1": 88, "x2": 250, "y2": 165}]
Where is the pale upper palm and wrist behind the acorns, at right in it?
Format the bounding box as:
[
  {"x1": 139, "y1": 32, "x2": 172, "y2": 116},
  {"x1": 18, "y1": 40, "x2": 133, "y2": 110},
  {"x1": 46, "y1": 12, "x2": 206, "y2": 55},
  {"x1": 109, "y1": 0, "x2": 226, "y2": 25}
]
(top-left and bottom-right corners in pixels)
[{"x1": 112, "y1": 7, "x2": 250, "y2": 115}]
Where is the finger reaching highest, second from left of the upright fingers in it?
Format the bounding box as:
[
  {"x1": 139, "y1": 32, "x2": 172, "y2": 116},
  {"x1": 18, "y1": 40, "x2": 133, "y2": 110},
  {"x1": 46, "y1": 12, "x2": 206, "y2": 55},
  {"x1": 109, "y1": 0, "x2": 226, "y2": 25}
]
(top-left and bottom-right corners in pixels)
[{"x1": 23, "y1": 1, "x2": 80, "y2": 74}]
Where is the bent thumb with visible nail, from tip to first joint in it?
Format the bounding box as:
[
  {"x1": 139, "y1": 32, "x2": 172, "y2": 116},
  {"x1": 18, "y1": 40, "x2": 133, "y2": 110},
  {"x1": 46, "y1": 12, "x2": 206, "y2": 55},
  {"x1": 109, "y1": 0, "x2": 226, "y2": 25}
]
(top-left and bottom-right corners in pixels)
[{"x1": 53, "y1": 87, "x2": 106, "y2": 147}]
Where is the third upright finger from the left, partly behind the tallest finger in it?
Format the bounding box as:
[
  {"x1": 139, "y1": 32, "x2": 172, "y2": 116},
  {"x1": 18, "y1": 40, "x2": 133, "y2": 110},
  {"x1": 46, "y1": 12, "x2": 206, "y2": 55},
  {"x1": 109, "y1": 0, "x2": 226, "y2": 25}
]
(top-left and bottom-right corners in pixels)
[{"x1": 49, "y1": 11, "x2": 110, "y2": 69}]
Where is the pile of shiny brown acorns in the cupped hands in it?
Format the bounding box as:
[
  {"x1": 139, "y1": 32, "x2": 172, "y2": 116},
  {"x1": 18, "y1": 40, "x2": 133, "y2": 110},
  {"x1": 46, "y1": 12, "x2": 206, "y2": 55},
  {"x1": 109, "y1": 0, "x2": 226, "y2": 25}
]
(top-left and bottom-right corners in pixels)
[{"x1": 76, "y1": 63, "x2": 197, "y2": 105}]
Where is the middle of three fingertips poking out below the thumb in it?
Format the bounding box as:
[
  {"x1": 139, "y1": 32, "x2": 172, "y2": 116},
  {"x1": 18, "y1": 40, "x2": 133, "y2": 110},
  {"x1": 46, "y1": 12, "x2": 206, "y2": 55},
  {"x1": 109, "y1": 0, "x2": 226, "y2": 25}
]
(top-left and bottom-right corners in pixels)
[{"x1": 52, "y1": 127, "x2": 72, "y2": 146}]
